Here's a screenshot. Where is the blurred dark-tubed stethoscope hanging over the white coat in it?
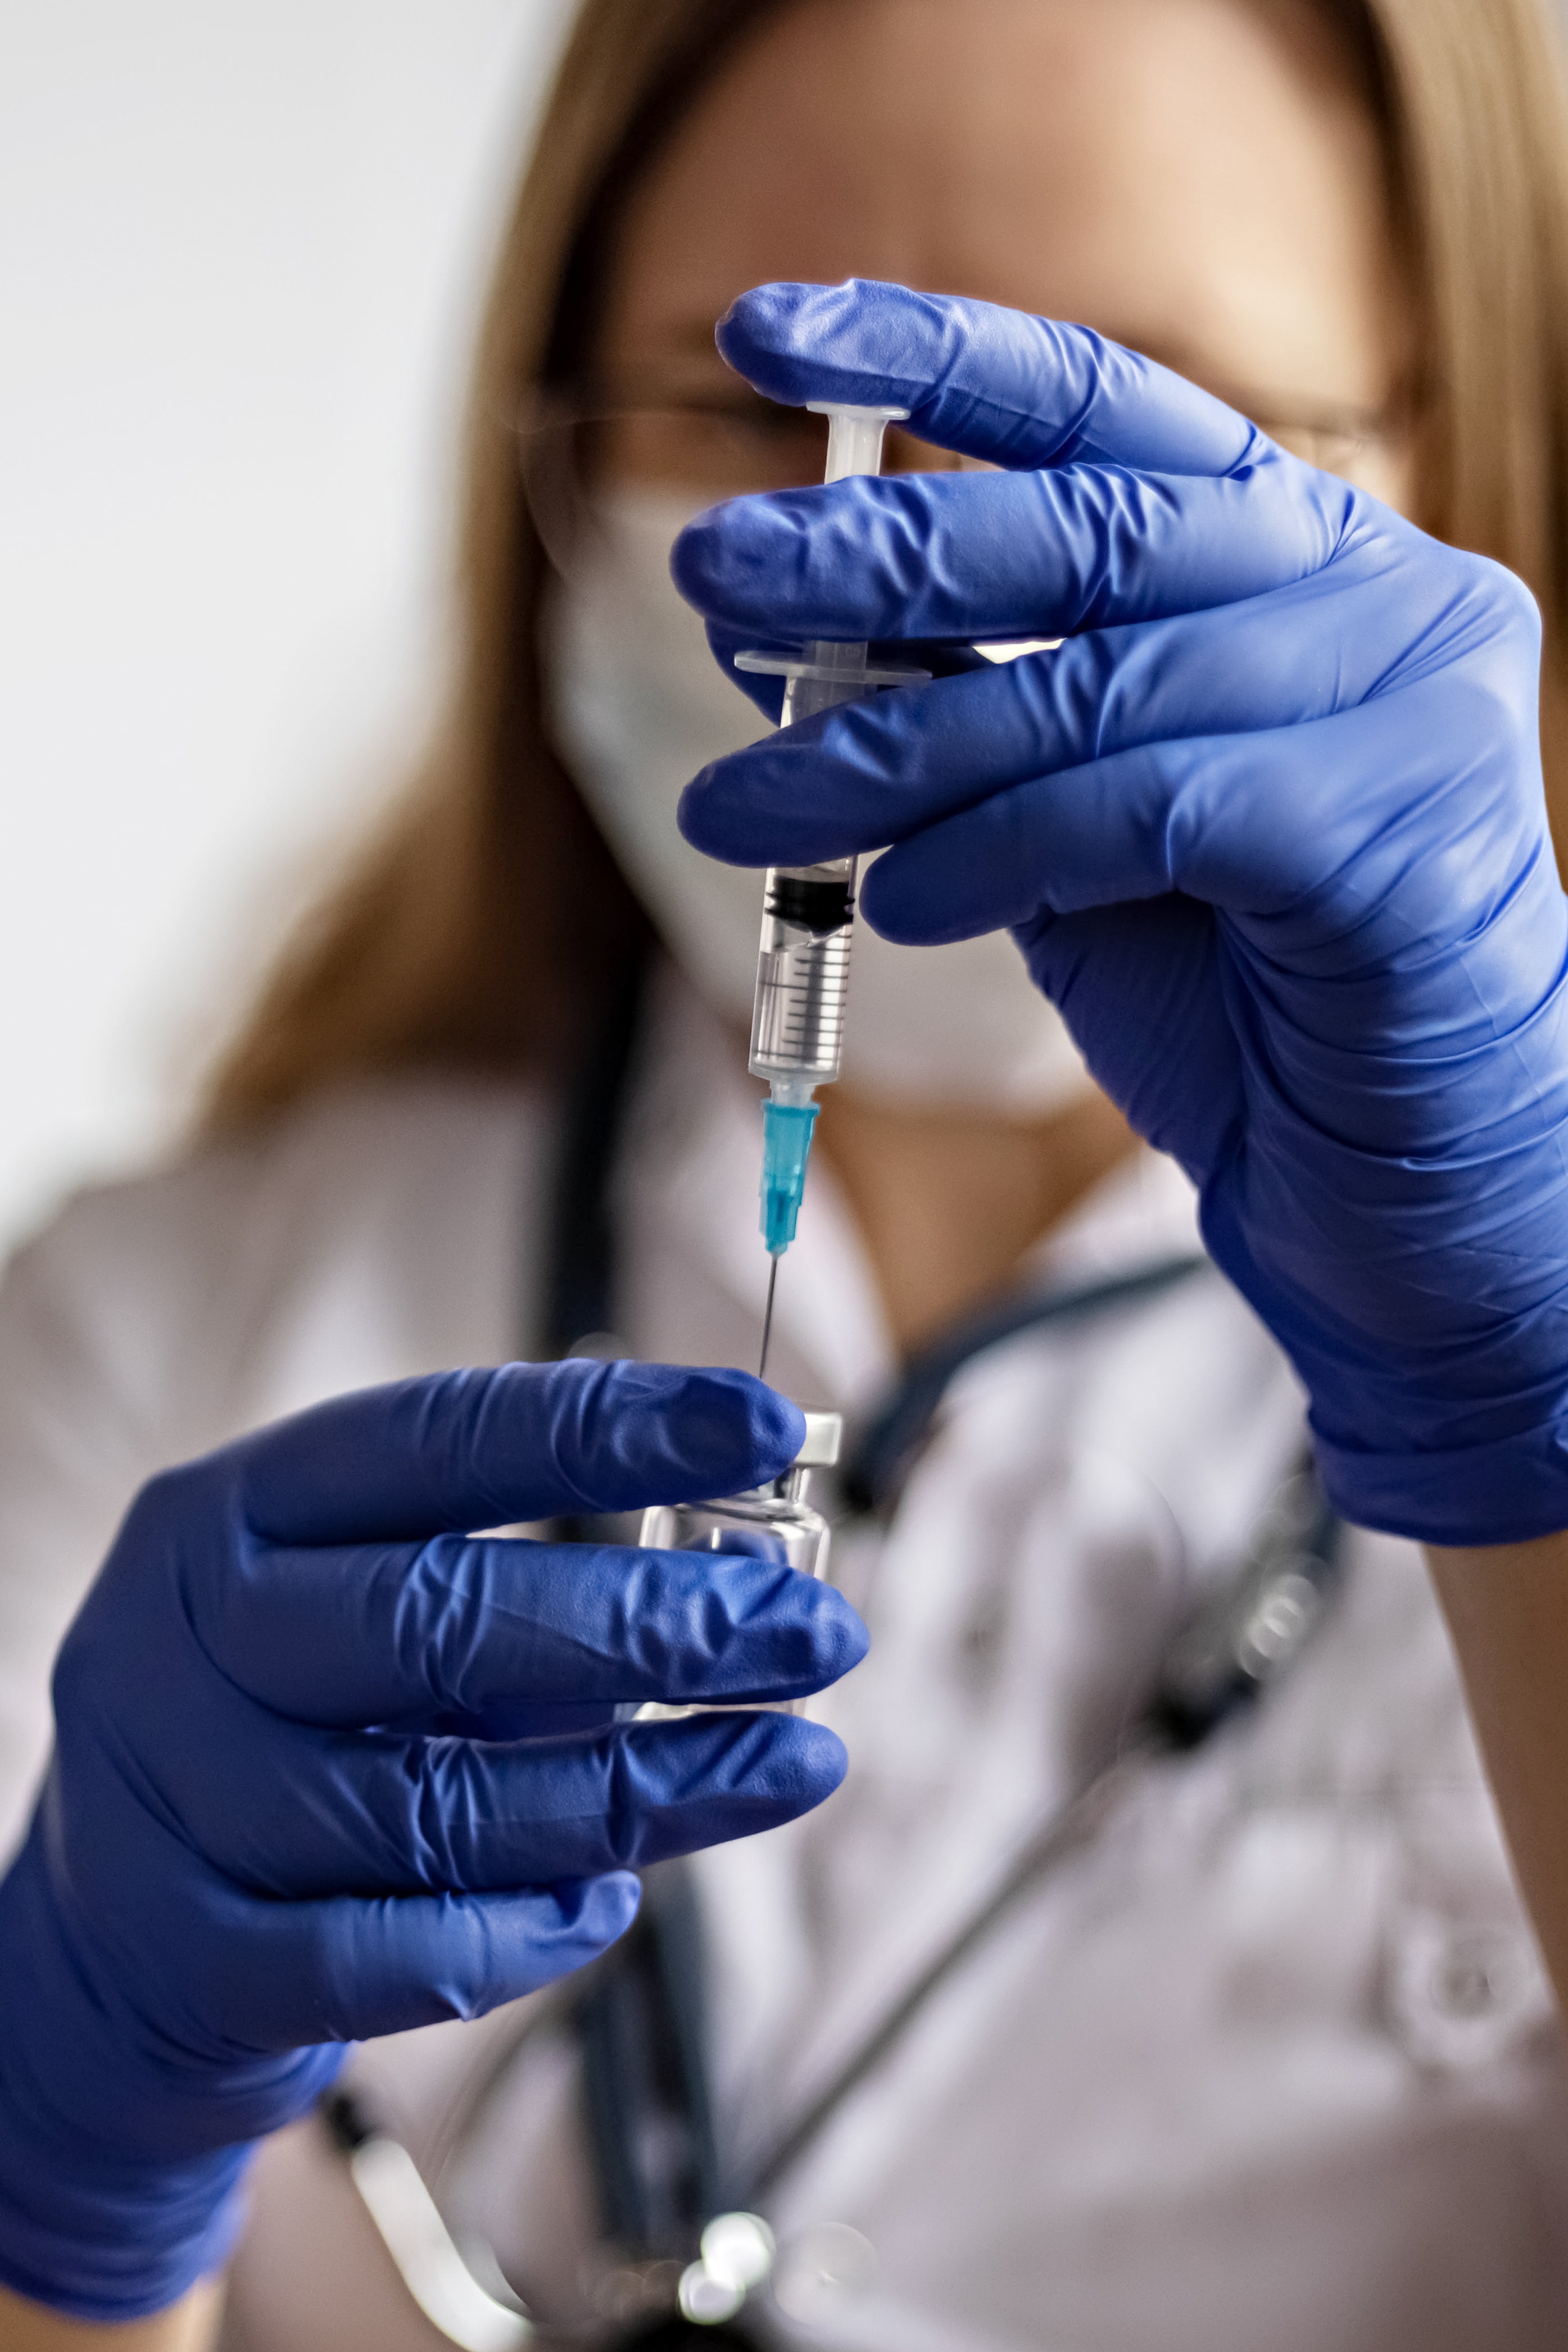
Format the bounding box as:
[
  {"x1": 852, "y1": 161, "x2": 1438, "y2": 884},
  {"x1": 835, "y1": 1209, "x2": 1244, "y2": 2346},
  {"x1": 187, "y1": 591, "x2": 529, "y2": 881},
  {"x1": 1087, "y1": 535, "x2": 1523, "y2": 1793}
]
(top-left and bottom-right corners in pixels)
[{"x1": 322, "y1": 964, "x2": 1340, "y2": 2352}]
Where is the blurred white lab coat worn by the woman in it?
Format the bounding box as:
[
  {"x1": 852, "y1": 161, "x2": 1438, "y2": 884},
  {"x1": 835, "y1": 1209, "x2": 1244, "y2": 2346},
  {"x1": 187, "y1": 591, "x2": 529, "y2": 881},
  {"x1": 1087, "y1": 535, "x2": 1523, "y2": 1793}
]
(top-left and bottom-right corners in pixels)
[{"x1": 0, "y1": 964, "x2": 1568, "y2": 2352}]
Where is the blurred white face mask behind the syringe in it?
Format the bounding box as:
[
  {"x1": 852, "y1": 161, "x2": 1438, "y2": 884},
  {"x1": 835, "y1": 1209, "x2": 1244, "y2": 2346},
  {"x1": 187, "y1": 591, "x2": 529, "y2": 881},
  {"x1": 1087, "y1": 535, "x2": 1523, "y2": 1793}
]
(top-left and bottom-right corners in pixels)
[{"x1": 545, "y1": 492, "x2": 1091, "y2": 1120}]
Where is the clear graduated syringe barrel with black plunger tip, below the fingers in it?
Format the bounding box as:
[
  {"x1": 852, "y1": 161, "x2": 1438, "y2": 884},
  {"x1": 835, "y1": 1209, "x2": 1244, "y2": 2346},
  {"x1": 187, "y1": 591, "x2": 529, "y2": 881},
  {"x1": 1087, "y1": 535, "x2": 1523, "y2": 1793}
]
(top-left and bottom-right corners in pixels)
[{"x1": 750, "y1": 859, "x2": 856, "y2": 1101}]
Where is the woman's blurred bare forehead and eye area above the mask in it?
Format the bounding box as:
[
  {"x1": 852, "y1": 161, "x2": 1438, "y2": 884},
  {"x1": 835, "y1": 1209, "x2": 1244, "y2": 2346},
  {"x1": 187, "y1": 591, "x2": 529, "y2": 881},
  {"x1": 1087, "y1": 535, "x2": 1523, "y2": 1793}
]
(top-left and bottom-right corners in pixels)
[{"x1": 597, "y1": 0, "x2": 1411, "y2": 510}]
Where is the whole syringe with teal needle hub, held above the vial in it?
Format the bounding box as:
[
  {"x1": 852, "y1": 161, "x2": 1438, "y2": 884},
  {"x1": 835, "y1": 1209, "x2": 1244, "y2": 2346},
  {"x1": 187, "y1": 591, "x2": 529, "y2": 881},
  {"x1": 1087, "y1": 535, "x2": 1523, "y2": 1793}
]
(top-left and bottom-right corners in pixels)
[{"x1": 736, "y1": 400, "x2": 928, "y2": 1369}]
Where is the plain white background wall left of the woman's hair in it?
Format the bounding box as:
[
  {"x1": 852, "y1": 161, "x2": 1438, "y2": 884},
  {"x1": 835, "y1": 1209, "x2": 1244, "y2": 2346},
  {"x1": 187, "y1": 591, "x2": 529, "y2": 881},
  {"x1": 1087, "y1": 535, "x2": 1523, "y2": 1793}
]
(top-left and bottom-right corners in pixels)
[{"x1": 0, "y1": 0, "x2": 581, "y2": 1244}]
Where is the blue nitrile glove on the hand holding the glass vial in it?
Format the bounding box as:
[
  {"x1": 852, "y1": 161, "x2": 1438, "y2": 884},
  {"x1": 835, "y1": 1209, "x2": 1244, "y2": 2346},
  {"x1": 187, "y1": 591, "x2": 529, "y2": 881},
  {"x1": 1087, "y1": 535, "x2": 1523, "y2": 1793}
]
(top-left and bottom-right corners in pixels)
[{"x1": 0, "y1": 1362, "x2": 865, "y2": 2319}]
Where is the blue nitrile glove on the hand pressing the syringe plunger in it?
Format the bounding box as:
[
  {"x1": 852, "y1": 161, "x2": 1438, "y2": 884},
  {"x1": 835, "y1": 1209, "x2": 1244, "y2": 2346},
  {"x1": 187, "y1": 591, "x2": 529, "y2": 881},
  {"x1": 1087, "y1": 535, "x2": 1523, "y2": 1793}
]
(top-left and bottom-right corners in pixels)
[{"x1": 674, "y1": 284, "x2": 1568, "y2": 1543}]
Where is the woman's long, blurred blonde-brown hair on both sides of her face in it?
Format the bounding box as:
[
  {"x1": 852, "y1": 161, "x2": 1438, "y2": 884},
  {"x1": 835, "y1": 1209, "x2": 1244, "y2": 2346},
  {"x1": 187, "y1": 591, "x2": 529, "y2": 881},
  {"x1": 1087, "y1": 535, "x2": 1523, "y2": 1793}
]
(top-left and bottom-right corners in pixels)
[{"x1": 207, "y1": 0, "x2": 1568, "y2": 1131}]
